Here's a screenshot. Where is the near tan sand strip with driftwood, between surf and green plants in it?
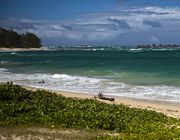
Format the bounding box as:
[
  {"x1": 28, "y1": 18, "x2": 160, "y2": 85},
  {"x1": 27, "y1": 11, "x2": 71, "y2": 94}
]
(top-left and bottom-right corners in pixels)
[{"x1": 22, "y1": 86, "x2": 180, "y2": 118}]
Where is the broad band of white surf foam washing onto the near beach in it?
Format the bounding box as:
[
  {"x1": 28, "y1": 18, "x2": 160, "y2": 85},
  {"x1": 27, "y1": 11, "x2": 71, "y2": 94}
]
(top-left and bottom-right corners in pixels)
[{"x1": 0, "y1": 68, "x2": 180, "y2": 102}]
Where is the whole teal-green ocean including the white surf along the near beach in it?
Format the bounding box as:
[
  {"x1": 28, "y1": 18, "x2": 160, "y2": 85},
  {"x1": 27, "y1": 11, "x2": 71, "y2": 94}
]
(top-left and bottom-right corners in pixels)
[{"x1": 0, "y1": 46, "x2": 180, "y2": 103}]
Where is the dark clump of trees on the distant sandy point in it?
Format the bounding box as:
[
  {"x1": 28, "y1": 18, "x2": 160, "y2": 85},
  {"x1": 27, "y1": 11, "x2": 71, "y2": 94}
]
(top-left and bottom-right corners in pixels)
[{"x1": 0, "y1": 28, "x2": 41, "y2": 48}]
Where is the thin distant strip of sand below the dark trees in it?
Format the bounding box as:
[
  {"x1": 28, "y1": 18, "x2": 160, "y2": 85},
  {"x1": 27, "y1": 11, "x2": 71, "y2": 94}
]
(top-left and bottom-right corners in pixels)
[{"x1": 0, "y1": 47, "x2": 46, "y2": 52}]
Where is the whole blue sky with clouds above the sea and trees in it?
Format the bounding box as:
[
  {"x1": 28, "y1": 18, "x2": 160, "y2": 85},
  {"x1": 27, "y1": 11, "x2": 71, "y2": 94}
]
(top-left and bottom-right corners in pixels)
[{"x1": 0, "y1": 0, "x2": 180, "y2": 45}]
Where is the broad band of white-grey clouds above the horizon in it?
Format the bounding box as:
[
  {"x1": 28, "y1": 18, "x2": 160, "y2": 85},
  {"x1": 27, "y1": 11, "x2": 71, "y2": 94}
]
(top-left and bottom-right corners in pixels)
[{"x1": 0, "y1": 6, "x2": 180, "y2": 45}]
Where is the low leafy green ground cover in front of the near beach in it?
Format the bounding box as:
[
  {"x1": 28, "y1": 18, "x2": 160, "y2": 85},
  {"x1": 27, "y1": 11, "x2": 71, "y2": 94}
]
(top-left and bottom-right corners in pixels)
[{"x1": 0, "y1": 84, "x2": 180, "y2": 140}]
